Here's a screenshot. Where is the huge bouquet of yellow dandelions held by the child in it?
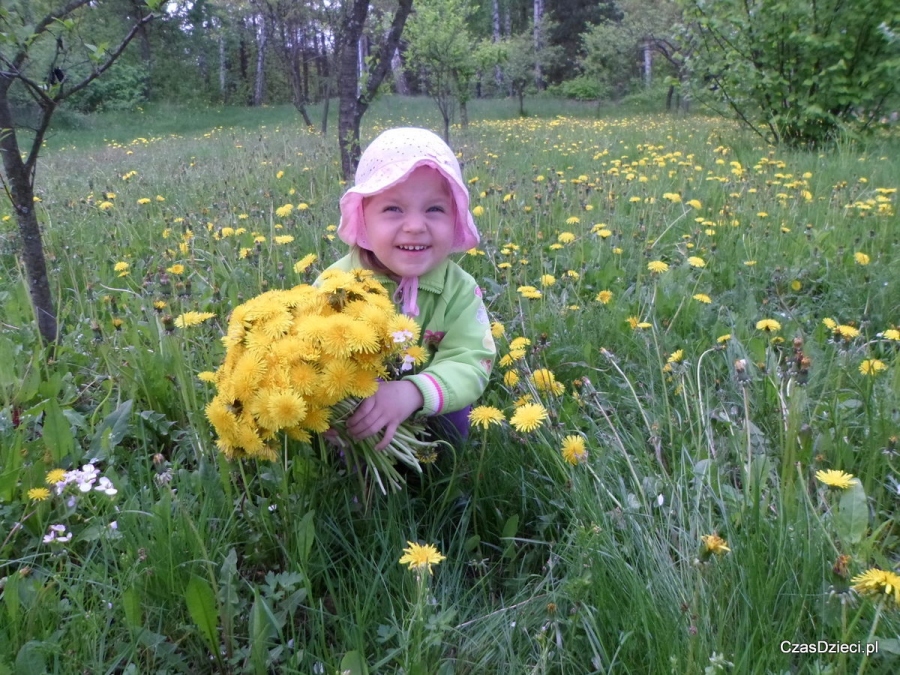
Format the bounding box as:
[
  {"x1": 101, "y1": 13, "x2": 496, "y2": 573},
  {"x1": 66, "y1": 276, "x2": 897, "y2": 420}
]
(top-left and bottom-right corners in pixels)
[{"x1": 206, "y1": 270, "x2": 435, "y2": 493}]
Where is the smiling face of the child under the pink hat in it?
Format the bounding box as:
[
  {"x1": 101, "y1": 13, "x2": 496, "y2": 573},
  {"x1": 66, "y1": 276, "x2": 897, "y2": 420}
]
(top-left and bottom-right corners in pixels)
[{"x1": 363, "y1": 166, "x2": 456, "y2": 277}]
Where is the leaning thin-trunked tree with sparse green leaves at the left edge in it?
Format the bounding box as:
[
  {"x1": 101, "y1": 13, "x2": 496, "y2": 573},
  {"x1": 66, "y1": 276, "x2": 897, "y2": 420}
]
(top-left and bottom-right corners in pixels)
[{"x1": 0, "y1": 0, "x2": 159, "y2": 343}]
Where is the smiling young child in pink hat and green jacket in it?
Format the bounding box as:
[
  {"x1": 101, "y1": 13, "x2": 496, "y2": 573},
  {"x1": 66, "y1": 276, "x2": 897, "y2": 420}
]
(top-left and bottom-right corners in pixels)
[{"x1": 320, "y1": 128, "x2": 496, "y2": 450}]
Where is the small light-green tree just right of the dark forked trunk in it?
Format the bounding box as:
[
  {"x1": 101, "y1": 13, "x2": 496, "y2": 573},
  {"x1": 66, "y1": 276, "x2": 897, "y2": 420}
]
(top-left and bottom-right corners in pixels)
[{"x1": 406, "y1": 0, "x2": 477, "y2": 143}]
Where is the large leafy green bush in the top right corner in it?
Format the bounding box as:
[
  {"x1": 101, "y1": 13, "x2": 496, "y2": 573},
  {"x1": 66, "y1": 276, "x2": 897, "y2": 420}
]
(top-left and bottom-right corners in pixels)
[{"x1": 682, "y1": 0, "x2": 900, "y2": 146}]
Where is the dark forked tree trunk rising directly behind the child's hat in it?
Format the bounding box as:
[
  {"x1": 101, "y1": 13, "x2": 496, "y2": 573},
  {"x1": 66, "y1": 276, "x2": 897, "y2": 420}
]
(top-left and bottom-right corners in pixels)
[{"x1": 336, "y1": 0, "x2": 413, "y2": 180}]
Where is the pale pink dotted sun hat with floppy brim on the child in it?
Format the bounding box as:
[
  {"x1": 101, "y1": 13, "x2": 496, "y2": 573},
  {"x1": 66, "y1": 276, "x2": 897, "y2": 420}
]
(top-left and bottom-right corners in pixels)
[{"x1": 338, "y1": 127, "x2": 480, "y2": 253}]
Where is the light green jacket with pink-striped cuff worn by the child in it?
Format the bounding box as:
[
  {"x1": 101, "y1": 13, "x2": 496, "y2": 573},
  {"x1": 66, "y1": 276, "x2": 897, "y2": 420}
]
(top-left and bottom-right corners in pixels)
[{"x1": 320, "y1": 251, "x2": 497, "y2": 415}]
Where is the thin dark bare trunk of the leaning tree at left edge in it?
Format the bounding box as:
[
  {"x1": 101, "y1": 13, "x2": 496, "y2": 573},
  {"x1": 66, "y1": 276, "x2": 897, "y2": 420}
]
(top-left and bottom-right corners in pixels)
[{"x1": 0, "y1": 90, "x2": 58, "y2": 344}]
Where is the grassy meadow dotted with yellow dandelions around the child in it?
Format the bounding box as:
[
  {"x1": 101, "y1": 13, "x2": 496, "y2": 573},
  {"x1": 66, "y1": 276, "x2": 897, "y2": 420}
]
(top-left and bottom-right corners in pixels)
[{"x1": 0, "y1": 98, "x2": 900, "y2": 675}]
